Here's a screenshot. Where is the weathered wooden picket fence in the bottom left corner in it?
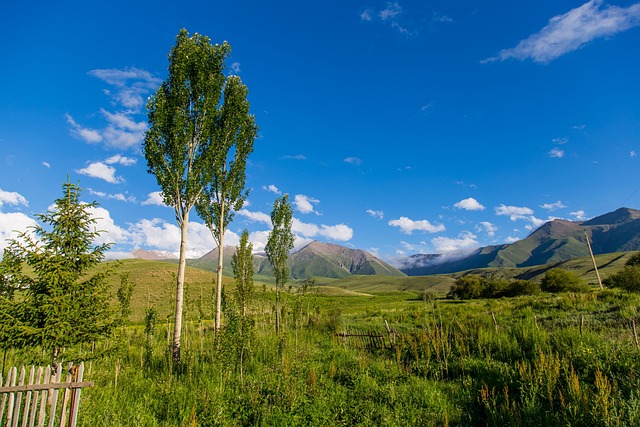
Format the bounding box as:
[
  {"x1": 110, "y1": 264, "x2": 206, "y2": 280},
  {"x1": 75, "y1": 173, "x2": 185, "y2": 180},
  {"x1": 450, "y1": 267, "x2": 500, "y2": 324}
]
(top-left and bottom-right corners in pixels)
[{"x1": 0, "y1": 363, "x2": 93, "y2": 427}]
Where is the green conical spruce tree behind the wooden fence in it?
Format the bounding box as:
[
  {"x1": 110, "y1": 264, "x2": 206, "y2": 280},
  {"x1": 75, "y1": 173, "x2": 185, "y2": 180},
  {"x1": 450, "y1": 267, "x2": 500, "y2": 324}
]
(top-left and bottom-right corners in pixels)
[{"x1": 0, "y1": 183, "x2": 117, "y2": 363}]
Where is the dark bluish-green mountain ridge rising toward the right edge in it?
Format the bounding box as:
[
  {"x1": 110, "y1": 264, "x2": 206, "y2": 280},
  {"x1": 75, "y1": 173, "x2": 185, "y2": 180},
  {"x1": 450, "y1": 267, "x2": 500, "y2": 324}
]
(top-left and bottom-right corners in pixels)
[{"x1": 400, "y1": 208, "x2": 640, "y2": 276}]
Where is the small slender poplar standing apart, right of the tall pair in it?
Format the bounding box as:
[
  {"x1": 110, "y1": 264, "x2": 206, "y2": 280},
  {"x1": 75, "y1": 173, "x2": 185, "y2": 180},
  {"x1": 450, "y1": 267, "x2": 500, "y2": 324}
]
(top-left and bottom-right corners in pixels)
[{"x1": 265, "y1": 194, "x2": 294, "y2": 334}]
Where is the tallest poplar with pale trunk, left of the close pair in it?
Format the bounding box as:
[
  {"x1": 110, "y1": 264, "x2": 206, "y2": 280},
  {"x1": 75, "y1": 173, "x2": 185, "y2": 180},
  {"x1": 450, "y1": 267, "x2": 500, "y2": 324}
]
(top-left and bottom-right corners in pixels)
[{"x1": 144, "y1": 29, "x2": 231, "y2": 363}]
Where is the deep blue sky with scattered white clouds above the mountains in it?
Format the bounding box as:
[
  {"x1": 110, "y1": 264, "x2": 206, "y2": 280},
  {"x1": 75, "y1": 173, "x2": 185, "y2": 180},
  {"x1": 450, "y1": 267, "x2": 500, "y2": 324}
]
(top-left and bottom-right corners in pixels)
[{"x1": 0, "y1": 0, "x2": 640, "y2": 261}]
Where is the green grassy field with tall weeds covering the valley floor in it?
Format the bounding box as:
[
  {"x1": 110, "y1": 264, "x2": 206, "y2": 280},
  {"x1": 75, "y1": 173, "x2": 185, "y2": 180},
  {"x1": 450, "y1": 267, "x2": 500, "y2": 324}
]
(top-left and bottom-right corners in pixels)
[{"x1": 7, "y1": 254, "x2": 640, "y2": 427}]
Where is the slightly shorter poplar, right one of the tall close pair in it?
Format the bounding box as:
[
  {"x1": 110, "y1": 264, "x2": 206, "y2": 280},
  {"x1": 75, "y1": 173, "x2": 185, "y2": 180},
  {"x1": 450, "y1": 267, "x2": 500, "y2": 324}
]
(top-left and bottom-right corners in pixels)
[{"x1": 196, "y1": 76, "x2": 258, "y2": 331}]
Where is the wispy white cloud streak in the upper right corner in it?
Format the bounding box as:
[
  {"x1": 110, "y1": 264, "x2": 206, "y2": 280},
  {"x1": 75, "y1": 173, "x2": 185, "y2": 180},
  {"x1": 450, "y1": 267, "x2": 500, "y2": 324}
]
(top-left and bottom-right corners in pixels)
[{"x1": 483, "y1": 0, "x2": 640, "y2": 63}]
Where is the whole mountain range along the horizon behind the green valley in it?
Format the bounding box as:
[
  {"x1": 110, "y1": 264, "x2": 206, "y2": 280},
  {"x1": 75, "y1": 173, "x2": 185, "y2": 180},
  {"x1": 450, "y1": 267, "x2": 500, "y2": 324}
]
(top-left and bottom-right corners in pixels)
[{"x1": 134, "y1": 208, "x2": 640, "y2": 280}]
